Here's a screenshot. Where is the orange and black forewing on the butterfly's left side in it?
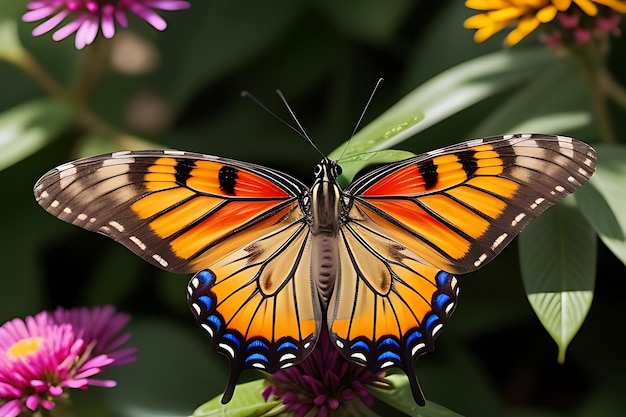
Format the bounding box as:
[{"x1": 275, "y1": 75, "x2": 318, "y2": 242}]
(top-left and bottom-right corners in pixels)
[{"x1": 34, "y1": 151, "x2": 306, "y2": 273}]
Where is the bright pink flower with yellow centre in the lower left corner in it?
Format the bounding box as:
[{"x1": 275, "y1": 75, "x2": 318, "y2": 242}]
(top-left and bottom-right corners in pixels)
[{"x1": 0, "y1": 306, "x2": 135, "y2": 417}]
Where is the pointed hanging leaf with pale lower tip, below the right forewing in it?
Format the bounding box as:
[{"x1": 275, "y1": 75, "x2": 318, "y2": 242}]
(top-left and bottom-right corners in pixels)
[{"x1": 519, "y1": 197, "x2": 597, "y2": 362}]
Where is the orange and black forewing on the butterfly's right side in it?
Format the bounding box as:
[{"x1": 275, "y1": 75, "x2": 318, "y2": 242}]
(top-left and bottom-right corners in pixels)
[{"x1": 346, "y1": 134, "x2": 595, "y2": 273}]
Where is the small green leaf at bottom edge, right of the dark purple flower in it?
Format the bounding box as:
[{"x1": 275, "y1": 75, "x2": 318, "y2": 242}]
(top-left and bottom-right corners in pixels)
[{"x1": 369, "y1": 374, "x2": 460, "y2": 417}]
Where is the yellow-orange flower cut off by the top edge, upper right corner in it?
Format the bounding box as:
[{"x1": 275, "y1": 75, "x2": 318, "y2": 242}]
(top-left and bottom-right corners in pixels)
[{"x1": 463, "y1": 0, "x2": 626, "y2": 46}]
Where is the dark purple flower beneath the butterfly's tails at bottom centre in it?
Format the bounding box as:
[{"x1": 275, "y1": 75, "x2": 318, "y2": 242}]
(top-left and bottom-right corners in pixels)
[{"x1": 262, "y1": 328, "x2": 389, "y2": 417}]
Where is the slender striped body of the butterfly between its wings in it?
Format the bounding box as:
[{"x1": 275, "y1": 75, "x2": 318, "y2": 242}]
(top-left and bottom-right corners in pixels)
[{"x1": 310, "y1": 159, "x2": 341, "y2": 306}]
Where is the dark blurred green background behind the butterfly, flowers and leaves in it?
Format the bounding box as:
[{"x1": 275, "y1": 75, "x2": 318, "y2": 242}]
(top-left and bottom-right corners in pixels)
[{"x1": 0, "y1": 0, "x2": 626, "y2": 417}]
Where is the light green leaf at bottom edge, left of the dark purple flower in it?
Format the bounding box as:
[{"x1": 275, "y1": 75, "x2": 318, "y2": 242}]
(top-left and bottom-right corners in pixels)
[{"x1": 192, "y1": 379, "x2": 281, "y2": 417}]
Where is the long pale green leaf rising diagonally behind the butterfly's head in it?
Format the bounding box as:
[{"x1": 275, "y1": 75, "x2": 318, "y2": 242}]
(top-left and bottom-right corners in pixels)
[{"x1": 329, "y1": 49, "x2": 546, "y2": 159}]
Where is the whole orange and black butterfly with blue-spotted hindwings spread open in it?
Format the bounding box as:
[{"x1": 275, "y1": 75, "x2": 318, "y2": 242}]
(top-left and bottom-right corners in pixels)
[{"x1": 34, "y1": 134, "x2": 595, "y2": 405}]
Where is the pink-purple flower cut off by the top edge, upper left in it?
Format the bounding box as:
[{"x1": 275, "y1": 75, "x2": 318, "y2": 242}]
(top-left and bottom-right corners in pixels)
[{"x1": 22, "y1": 0, "x2": 191, "y2": 49}]
